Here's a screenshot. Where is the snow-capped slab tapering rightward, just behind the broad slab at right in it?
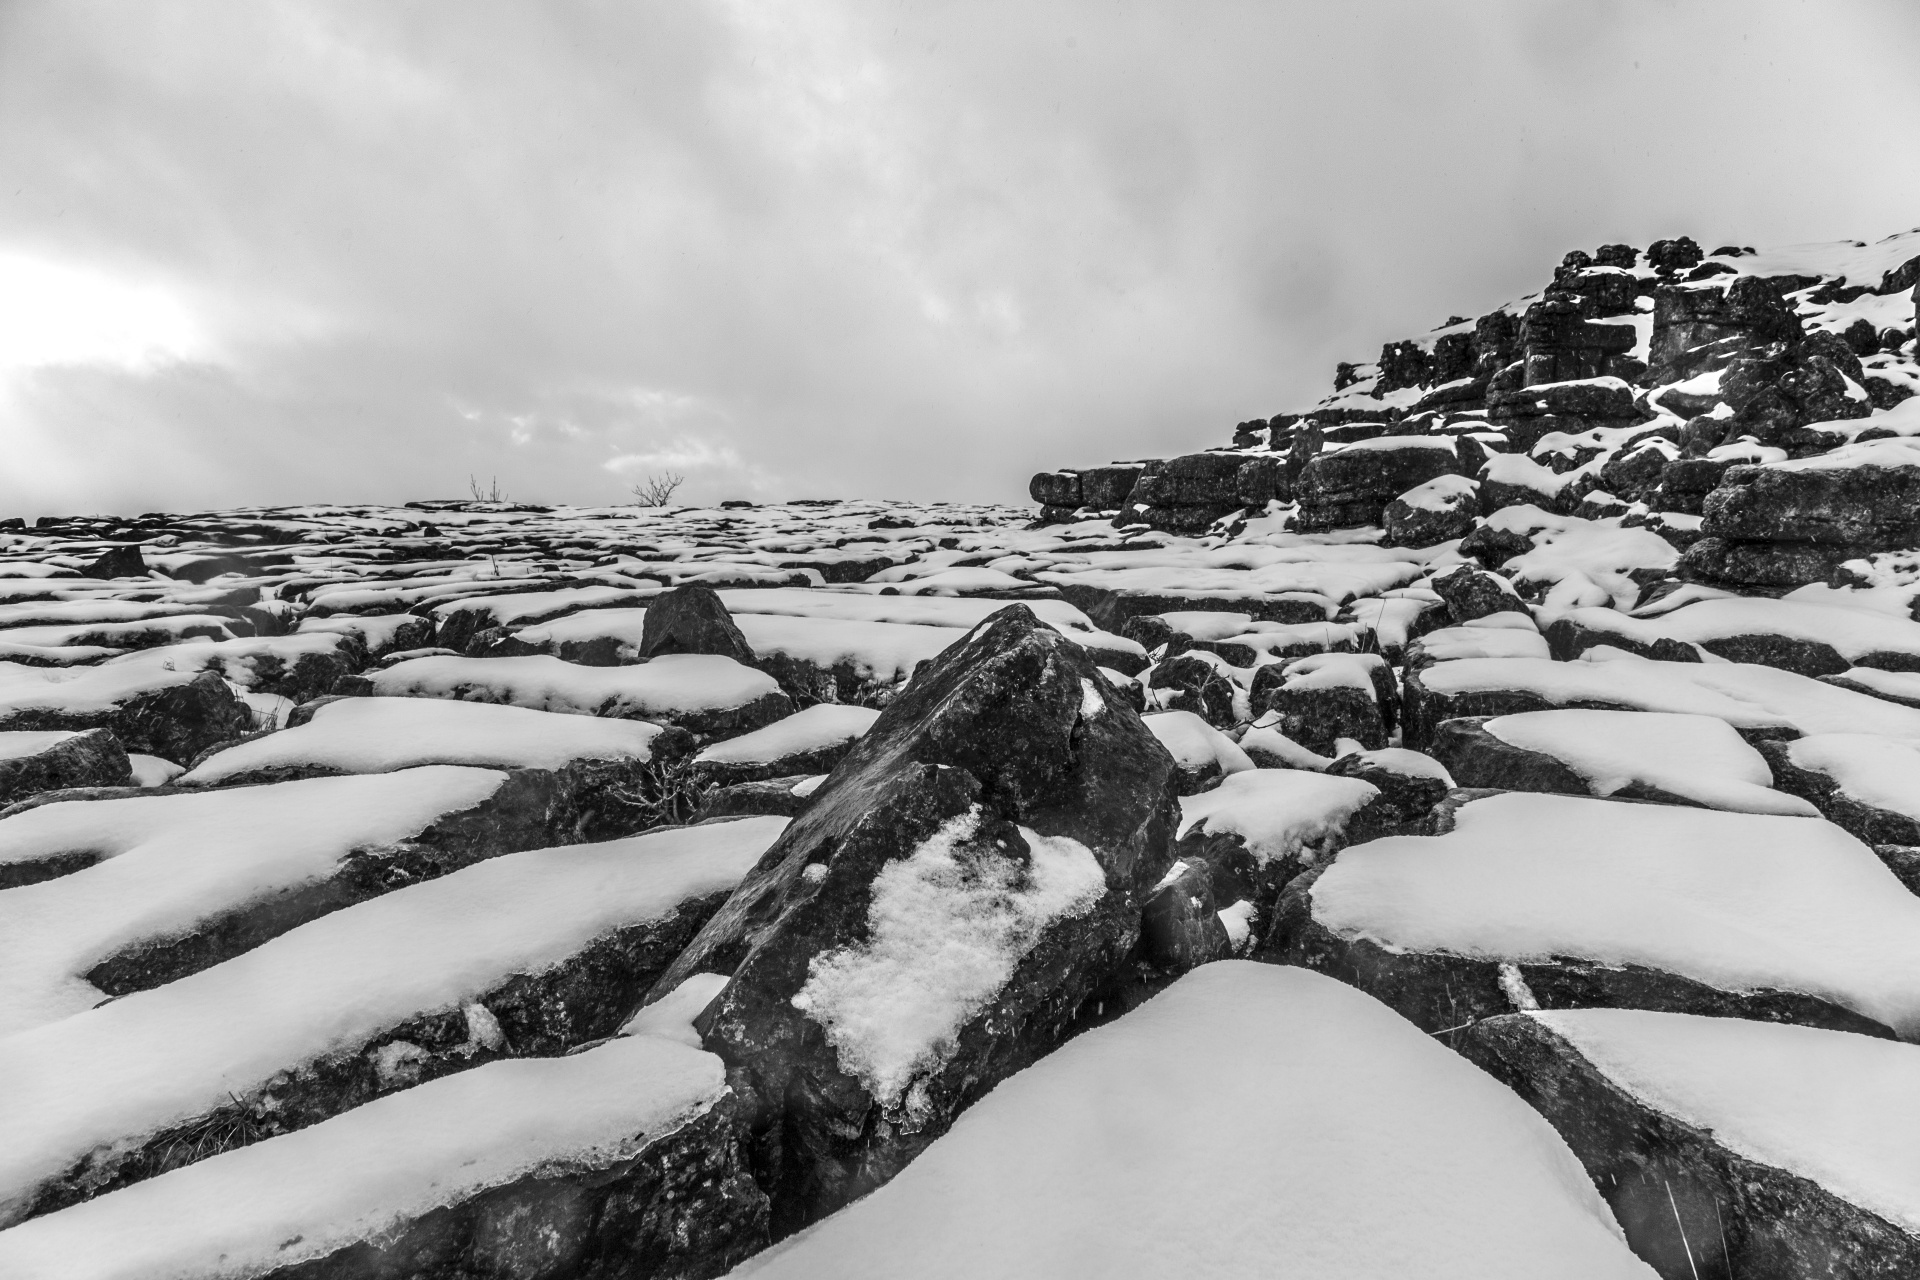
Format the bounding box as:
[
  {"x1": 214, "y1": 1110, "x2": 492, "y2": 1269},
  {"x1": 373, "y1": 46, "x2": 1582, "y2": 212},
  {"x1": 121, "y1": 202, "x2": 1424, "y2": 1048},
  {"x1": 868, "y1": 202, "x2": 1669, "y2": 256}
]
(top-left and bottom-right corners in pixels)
[{"x1": 1430, "y1": 710, "x2": 1820, "y2": 818}]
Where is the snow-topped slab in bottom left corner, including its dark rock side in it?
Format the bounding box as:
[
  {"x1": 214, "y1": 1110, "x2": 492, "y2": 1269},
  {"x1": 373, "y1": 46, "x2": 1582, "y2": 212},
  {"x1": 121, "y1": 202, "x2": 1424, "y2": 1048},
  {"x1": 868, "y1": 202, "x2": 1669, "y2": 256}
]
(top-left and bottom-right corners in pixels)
[{"x1": 0, "y1": 1036, "x2": 766, "y2": 1280}]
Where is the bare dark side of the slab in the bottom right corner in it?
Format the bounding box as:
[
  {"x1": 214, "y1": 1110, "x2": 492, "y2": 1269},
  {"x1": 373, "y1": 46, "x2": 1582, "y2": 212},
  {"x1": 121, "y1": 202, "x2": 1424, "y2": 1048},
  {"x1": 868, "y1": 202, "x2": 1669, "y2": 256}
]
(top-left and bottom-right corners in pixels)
[{"x1": 1452, "y1": 1013, "x2": 1920, "y2": 1280}]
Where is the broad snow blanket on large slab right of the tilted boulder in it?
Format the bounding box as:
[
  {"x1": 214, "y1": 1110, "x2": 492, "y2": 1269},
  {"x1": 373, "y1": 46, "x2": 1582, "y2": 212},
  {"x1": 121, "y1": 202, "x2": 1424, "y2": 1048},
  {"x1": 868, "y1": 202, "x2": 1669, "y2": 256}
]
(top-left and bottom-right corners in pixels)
[{"x1": 1311, "y1": 793, "x2": 1920, "y2": 1038}]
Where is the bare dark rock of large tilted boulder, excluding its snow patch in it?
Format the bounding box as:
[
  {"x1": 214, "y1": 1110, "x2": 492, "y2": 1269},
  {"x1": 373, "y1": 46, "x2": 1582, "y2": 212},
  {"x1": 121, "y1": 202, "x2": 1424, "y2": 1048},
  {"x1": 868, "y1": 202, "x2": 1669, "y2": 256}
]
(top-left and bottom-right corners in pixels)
[{"x1": 655, "y1": 604, "x2": 1177, "y2": 1232}]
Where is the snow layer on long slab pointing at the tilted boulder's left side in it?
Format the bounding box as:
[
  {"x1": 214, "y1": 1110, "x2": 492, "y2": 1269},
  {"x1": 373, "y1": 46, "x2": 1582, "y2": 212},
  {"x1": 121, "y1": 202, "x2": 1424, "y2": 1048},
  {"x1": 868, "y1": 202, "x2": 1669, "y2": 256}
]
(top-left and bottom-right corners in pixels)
[{"x1": 0, "y1": 818, "x2": 787, "y2": 1222}]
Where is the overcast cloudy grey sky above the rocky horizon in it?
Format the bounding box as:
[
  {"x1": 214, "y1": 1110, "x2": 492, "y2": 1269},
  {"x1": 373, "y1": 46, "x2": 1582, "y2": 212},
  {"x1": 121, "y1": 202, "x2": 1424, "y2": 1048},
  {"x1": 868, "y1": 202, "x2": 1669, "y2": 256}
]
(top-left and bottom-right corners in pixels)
[{"x1": 0, "y1": 0, "x2": 1920, "y2": 520}]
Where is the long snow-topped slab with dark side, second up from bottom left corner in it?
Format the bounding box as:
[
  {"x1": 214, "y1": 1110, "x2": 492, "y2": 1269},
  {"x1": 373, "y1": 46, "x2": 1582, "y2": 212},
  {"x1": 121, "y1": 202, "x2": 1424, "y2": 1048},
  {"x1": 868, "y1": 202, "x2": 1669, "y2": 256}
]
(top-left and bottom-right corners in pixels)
[{"x1": 0, "y1": 818, "x2": 787, "y2": 1222}]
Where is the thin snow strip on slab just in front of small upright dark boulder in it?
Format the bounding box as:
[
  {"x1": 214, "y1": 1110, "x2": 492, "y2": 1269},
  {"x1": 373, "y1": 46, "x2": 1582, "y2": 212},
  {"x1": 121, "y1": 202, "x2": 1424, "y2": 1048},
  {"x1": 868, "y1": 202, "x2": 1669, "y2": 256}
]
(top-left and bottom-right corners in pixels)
[{"x1": 369, "y1": 652, "x2": 780, "y2": 722}]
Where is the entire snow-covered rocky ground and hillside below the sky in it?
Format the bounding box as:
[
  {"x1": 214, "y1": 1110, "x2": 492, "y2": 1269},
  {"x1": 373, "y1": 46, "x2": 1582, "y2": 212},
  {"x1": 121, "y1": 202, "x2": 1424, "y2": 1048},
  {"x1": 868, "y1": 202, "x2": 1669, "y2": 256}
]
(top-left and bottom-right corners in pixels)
[{"x1": 0, "y1": 232, "x2": 1920, "y2": 1280}]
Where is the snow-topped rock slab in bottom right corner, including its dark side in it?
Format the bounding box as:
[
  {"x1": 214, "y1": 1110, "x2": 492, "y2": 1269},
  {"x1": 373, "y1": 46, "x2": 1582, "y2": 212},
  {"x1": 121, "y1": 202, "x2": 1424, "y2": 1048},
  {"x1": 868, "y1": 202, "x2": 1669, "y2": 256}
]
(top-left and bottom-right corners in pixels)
[{"x1": 1455, "y1": 1009, "x2": 1920, "y2": 1280}]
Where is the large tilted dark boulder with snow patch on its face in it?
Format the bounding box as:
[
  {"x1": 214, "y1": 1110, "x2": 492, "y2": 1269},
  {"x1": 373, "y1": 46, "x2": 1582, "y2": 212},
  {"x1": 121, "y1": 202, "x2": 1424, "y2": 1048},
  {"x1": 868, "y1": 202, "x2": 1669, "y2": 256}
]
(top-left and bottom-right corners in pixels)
[{"x1": 655, "y1": 606, "x2": 1177, "y2": 1230}]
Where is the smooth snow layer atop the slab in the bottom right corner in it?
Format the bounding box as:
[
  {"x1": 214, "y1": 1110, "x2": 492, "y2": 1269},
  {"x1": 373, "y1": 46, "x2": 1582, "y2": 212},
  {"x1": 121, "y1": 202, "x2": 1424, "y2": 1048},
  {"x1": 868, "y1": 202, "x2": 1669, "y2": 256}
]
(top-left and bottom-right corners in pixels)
[{"x1": 1528, "y1": 1009, "x2": 1920, "y2": 1234}]
